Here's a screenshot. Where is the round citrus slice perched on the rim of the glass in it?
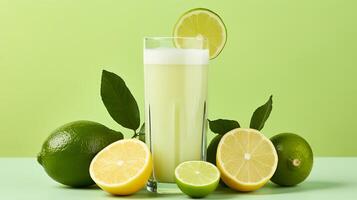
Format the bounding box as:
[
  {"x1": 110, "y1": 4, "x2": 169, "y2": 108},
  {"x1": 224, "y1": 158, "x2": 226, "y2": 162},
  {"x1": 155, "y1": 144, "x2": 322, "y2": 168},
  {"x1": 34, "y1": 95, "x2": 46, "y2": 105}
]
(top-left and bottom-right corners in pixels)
[{"x1": 174, "y1": 8, "x2": 227, "y2": 59}]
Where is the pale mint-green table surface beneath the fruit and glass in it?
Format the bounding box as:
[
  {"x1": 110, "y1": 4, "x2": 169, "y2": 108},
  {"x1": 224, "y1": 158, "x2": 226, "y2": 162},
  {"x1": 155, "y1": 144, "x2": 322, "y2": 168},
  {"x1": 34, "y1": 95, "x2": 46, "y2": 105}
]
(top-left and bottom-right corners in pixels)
[{"x1": 0, "y1": 157, "x2": 357, "y2": 200}]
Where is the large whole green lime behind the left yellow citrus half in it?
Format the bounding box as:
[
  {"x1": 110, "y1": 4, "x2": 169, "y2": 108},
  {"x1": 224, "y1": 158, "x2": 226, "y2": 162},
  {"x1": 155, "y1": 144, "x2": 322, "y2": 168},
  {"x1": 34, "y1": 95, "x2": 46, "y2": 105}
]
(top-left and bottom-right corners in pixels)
[{"x1": 37, "y1": 121, "x2": 123, "y2": 187}]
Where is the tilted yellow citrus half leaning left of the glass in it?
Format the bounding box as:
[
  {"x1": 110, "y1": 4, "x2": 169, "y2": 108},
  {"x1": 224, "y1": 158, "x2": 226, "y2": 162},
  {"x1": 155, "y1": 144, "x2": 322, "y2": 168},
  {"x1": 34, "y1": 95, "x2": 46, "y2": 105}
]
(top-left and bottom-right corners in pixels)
[{"x1": 89, "y1": 139, "x2": 152, "y2": 195}]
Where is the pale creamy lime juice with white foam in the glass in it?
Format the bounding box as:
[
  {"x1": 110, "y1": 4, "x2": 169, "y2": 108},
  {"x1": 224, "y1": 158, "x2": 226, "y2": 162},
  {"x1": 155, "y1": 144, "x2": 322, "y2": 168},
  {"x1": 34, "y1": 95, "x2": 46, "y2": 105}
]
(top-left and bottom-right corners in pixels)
[{"x1": 144, "y1": 48, "x2": 209, "y2": 183}]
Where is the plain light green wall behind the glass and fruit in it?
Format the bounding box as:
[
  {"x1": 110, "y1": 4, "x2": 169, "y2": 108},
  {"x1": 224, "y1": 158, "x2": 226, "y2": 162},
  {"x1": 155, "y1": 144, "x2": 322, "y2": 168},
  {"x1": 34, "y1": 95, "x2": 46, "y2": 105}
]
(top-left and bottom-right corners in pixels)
[{"x1": 0, "y1": 0, "x2": 357, "y2": 156}]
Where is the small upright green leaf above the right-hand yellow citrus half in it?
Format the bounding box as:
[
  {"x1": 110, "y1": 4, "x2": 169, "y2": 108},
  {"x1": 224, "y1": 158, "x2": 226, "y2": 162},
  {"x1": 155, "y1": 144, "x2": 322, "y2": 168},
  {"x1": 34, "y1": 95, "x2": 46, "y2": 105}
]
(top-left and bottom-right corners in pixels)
[{"x1": 250, "y1": 95, "x2": 273, "y2": 131}]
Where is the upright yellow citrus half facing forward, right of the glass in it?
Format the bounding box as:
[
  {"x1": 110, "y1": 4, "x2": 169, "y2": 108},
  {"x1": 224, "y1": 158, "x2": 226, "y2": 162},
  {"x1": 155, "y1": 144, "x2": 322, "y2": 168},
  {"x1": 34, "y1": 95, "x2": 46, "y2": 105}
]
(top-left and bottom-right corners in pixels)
[{"x1": 216, "y1": 128, "x2": 278, "y2": 191}]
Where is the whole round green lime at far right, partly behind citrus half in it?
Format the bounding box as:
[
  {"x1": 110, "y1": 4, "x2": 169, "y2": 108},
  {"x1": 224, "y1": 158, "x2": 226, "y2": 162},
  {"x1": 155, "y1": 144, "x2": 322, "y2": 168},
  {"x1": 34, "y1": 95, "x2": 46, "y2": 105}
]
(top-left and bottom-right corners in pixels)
[{"x1": 270, "y1": 133, "x2": 313, "y2": 186}]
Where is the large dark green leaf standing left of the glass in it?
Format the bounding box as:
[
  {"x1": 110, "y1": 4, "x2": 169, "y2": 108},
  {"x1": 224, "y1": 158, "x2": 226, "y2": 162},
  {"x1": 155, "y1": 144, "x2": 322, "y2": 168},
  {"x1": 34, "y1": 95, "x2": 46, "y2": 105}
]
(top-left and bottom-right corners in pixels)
[{"x1": 100, "y1": 70, "x2": 140, "y2": 131}]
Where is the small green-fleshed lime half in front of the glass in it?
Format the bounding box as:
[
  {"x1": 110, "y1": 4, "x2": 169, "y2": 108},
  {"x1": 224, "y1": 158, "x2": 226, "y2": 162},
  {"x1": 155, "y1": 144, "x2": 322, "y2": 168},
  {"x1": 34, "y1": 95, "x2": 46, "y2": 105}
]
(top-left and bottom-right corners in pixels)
[{"x1": 175, "y1": 161, "x2": 220, "y2": 198}]
